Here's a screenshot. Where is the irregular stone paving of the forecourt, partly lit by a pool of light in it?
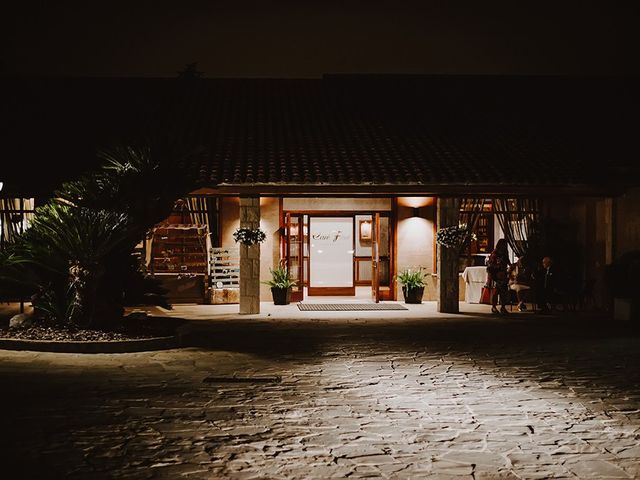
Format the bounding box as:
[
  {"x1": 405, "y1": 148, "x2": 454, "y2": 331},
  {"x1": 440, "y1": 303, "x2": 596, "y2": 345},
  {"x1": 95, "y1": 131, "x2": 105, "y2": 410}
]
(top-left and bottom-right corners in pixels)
[{"x1": 0, "y1": 315, "x2": 640, "y2": 479}]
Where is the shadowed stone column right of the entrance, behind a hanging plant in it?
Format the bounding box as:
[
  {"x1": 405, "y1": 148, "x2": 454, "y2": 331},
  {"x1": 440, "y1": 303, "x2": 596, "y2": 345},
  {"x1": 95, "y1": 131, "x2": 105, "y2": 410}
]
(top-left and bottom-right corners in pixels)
[{"x1": 437, "y1": 197, "x2": 460, "y2": 313}]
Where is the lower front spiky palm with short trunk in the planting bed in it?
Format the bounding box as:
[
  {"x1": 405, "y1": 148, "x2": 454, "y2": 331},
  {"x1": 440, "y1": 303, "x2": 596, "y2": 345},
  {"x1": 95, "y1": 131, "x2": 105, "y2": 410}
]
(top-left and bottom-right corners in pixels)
[{"x1": 5, "y1": 201, "x2": 130, "y2": 327}]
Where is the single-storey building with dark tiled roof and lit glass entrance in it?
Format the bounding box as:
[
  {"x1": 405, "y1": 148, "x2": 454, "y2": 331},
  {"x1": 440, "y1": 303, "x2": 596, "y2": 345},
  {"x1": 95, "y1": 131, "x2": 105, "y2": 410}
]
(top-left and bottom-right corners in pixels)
[{"x1": 0, "y1": 76, "x2": 640, "y2": 312}]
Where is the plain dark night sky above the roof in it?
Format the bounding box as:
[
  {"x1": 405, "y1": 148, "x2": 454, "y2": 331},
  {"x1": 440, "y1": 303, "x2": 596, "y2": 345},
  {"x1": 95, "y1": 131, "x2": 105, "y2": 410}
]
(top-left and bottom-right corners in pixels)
[{"x1": 5, "y1": 0, "x2": 640, "y2": 77}]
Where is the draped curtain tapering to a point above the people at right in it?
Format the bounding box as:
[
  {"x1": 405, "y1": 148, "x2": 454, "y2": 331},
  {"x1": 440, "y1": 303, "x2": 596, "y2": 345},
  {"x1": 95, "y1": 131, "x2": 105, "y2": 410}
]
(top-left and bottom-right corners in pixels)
[{"x1": 493, "y1": 198, "x2": 540, "y2": 257}]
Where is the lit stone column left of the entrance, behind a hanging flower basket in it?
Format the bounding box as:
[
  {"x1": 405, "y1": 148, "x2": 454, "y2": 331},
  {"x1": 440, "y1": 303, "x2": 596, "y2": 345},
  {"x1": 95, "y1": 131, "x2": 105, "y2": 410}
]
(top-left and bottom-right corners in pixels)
[{"x1": 240, "y1": 197, "x2": 260, "y2": 314}]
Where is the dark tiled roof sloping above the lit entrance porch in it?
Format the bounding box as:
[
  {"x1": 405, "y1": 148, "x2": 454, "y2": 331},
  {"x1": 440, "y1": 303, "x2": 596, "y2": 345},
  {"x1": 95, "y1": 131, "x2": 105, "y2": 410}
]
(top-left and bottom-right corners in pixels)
[{"x1": 1, "y1": 77, "x2": 636, "y2": 196}]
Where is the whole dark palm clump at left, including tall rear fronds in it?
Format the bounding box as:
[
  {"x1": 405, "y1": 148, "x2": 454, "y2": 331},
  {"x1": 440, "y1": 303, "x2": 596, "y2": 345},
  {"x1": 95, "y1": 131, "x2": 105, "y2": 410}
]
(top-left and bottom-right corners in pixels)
[{"x1": 0, "y1": 140, "x2": 201, "y2": 328}]
